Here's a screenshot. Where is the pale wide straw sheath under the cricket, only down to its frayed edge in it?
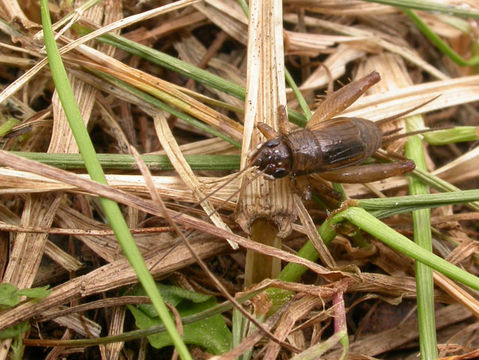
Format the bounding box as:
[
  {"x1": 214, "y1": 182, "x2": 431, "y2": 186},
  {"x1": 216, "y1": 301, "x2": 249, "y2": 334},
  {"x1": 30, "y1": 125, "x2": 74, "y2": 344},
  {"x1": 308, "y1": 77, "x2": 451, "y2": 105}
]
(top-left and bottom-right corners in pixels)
[{"x1": 237, "y1": 1, "x2": 295, "y2": 234}]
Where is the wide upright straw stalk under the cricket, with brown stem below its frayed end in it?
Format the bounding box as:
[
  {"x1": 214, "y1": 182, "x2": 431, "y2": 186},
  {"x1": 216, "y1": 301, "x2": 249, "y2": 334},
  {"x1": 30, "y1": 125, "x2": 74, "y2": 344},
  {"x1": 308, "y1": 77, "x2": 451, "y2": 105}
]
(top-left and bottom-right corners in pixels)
[{"x1": 236, "y1": 0, "x2": 296, "y2": 284}]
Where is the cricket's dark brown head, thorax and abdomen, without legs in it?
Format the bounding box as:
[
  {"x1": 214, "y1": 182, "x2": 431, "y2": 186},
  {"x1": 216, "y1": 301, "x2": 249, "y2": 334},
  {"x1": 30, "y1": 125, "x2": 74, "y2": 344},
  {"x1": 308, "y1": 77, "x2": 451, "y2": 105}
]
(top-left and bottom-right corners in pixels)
[{"x1": 251, "y1": 118, "x2": 382, "y2": 178}]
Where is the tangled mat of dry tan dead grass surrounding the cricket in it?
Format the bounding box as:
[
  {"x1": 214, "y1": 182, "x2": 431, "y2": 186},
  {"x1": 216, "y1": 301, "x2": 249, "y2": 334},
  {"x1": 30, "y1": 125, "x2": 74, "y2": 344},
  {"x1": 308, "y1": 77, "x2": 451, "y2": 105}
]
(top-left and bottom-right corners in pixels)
[{"x1": 0, "y1": 0, "x2": 479, "y2": 359}]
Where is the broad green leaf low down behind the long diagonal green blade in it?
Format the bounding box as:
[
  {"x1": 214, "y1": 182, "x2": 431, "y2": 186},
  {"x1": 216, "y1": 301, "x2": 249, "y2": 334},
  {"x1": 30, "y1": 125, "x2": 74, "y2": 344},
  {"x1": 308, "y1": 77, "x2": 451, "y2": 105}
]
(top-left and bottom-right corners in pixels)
[{"x1": 128, "y1": 284, "x2": 231, "y2": 354}]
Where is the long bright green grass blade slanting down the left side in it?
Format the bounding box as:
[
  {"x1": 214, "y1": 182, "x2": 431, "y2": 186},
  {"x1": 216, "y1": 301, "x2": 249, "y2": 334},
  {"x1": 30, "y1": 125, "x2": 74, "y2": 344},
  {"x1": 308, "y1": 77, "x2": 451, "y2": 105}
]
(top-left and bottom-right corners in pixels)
[{"x1": 41, "y1": 0, "x2": 191, "y2": 359}]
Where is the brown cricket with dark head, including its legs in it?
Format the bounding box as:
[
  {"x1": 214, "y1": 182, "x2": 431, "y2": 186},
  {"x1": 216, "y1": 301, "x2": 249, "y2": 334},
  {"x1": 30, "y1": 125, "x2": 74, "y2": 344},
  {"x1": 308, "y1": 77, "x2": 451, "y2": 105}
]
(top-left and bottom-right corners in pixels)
[{"x1": 250, "y1": 72, "x2": 433, "y2": 187}]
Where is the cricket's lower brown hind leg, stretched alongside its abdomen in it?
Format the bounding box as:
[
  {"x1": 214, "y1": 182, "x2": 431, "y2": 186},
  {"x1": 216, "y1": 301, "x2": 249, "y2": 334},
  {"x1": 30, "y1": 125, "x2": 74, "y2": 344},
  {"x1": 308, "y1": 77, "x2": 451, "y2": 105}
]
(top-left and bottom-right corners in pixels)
[{"x1": 320, "y1": 160, "x2": 416, "y2": 184}]
